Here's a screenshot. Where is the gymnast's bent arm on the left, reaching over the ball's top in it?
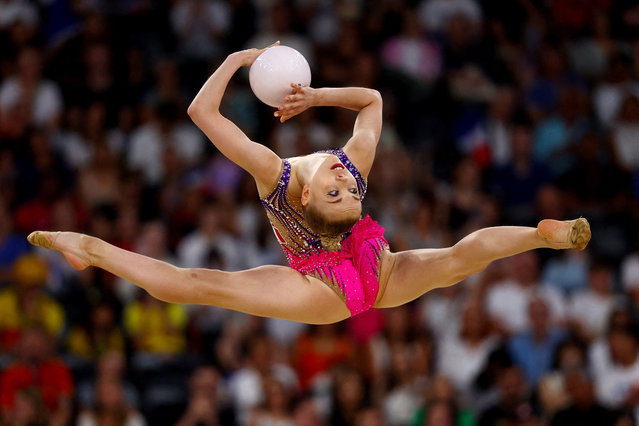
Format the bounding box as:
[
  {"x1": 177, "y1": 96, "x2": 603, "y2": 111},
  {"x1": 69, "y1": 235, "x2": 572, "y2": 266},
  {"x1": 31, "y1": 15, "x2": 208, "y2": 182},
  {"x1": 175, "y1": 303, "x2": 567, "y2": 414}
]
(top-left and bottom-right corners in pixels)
[{"x1": 188, "y1": 42, "x2": 282, "y2": 194}]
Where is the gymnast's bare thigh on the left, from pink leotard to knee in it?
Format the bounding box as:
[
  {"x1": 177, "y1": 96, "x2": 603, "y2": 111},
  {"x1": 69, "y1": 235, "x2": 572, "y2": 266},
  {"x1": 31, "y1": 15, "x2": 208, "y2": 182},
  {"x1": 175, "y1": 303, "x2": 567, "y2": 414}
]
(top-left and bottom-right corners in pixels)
[{"x1": 198, "y1": 265, "x2": 350, "y2": 324}]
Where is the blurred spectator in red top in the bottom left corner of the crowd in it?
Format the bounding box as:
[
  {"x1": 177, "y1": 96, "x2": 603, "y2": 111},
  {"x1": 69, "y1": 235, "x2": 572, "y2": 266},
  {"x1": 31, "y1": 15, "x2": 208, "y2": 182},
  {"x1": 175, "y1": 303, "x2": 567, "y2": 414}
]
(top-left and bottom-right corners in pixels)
[{"x1": 0, "y1": 327, "x2": 74, "y2": 426}]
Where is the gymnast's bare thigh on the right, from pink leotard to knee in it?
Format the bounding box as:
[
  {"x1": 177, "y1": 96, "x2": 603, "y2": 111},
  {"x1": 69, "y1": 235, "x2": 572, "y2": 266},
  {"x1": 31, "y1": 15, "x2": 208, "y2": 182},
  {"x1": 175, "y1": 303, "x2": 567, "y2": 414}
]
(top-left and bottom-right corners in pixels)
[{"x1": 375, "y1": 248, "x2": 465, "y2": 308}]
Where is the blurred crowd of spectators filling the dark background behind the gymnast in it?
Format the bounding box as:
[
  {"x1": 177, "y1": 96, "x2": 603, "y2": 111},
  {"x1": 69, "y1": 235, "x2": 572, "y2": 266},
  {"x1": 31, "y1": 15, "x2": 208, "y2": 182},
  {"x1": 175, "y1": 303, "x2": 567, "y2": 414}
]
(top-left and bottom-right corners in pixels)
[{"x1": 0, "y1": 0, "x2": 639, "y2": 426}]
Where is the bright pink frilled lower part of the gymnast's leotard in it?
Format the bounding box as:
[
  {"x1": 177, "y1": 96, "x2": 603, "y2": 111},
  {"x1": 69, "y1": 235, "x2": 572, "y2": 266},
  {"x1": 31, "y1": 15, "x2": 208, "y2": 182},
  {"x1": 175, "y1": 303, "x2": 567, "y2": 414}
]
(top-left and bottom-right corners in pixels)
[{"x1": 284, "y1": 216, "x2": 388, "y2": 315}]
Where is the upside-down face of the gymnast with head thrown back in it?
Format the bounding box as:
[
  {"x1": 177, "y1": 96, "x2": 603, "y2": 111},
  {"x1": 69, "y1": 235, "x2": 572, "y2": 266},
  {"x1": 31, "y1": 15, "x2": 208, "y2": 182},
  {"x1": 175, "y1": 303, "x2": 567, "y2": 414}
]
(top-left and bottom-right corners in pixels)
[{"x1": 302, "y1": 155, "x2": 362, "y2": 220}]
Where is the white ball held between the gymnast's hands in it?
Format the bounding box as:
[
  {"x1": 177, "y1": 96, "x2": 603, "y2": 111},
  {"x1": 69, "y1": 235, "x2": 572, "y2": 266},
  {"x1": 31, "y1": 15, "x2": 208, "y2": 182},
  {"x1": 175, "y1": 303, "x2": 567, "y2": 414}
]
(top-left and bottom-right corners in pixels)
[{"x1": 249, "y1": 46, "x2": 311, "y2": 107}]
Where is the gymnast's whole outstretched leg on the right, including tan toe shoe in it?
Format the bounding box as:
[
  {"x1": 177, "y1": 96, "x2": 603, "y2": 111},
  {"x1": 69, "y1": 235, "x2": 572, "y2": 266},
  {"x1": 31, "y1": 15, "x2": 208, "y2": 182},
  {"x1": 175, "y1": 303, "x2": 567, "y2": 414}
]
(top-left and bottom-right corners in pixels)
[{"x1": 375, "y1": 218, "x2": 590, "y2": 308}]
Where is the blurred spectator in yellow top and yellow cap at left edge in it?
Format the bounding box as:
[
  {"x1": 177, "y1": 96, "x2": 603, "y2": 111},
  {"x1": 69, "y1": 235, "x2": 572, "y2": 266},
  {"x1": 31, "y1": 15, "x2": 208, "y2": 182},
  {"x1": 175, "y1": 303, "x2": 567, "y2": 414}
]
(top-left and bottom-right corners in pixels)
[{"x1": 0, "y1": 254, "x2": 65, "y2": 351}]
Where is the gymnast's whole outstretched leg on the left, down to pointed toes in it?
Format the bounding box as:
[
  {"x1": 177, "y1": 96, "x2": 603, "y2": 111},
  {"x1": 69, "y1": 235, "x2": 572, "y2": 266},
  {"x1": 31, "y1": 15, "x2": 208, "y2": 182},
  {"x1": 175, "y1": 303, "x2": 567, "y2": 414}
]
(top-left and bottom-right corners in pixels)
[{"x1": 29, "y1": 231, "x2": 350, "y2": 324}]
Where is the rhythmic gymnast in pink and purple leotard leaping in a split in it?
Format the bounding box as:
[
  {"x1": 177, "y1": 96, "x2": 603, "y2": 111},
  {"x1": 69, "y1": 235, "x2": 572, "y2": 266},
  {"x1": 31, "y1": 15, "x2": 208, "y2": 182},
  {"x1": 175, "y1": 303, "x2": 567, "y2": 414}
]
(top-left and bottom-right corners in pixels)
[{"x1": 28, "y1": 44, "x2": 590, "y2": 324}]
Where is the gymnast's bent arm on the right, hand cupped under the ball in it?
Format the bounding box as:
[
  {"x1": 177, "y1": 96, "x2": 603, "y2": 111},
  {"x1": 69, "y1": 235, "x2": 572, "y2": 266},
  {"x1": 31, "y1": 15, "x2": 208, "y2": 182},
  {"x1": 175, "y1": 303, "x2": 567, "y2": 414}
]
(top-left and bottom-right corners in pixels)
[{"x1": 275, "y1": 85, "x2": 382, "y2": 179}]
